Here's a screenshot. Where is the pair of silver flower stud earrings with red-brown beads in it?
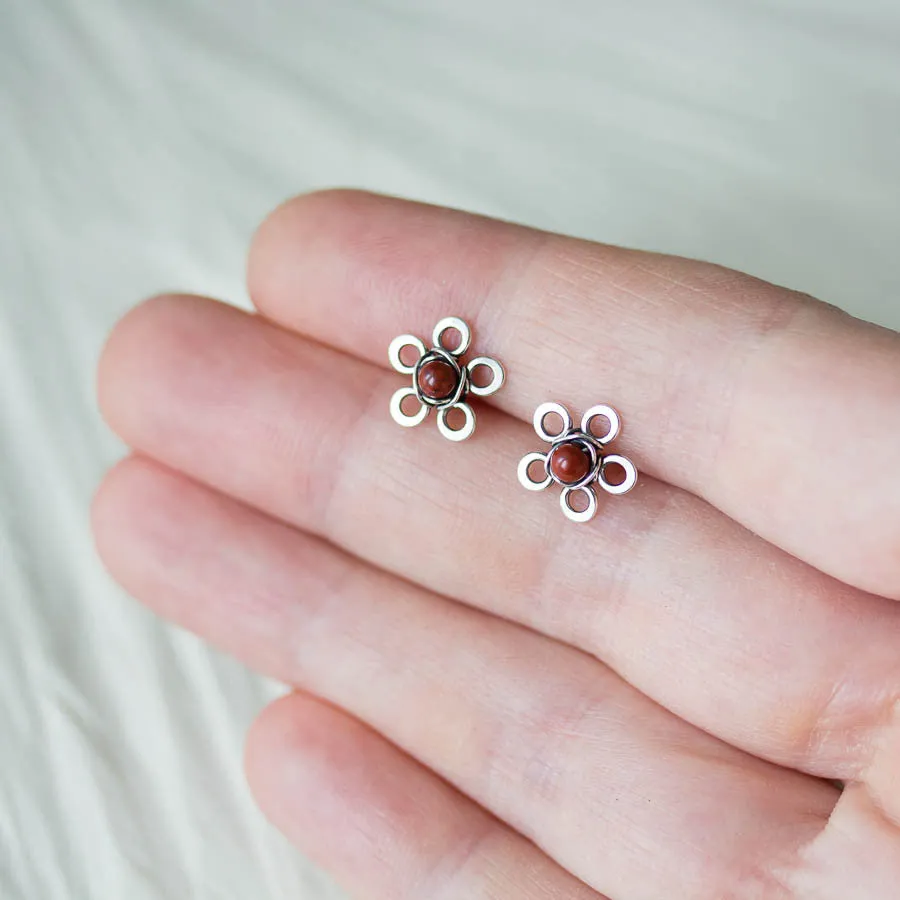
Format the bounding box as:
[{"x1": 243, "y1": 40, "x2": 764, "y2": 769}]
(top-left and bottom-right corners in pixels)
[{"x1": 388, "y1": 316, "x2": 637, "y2": 522}]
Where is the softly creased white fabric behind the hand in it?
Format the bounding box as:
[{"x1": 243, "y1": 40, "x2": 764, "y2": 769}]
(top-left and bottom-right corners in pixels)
[{"x1": 0, "y1": 0, "x2": 900, "y2": 900}]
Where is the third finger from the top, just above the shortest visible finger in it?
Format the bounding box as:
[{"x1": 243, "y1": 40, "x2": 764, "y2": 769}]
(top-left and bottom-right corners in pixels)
[{"x1": 95, "y1": 460, "x2": 836, "y2": 900}]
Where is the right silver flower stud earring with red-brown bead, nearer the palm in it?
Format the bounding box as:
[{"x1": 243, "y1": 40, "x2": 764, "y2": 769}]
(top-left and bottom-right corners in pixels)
[{"x1": 519, "y1": 403, "x2": 637, "y2": 522}]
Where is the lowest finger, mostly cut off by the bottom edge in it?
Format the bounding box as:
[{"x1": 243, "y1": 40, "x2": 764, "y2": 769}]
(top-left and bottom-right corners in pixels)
[{"x1": 247, "y1": 694, "x2": 602, "y2": 900}]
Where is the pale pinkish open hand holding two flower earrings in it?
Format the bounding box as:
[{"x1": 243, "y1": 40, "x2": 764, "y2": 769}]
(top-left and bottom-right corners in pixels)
[{"x1": 93, "y1": 191, "x2": 900, "y2": 900}]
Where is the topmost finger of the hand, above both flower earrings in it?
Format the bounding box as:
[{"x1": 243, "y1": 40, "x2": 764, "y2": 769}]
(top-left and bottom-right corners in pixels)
[{"x1": 249, "y1": 192, "x2": 900, "y2": 597}]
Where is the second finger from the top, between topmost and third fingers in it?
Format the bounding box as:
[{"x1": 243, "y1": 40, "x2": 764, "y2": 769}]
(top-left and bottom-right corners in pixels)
[{"x1": 95, "y1": 299, "x2": 900, "y2": 783}]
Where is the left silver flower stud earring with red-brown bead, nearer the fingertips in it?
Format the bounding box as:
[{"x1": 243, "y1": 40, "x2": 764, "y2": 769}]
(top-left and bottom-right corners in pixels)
[{"x1": 388, "y1": 316, "x2": 505, "y2": 441}]
